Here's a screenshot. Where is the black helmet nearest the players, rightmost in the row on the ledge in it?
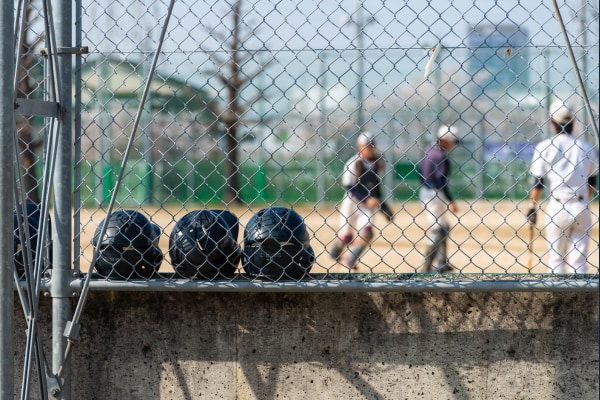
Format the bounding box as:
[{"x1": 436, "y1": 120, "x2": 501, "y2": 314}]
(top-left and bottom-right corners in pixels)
[{"x1": 242, "y1": 207, "x2": 315, "y2": 279}]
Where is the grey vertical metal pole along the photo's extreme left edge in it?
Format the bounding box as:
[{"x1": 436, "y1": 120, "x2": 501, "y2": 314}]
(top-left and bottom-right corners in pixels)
[{"x1": 0, "y1": 3, "x2": 15, "y2": 399}]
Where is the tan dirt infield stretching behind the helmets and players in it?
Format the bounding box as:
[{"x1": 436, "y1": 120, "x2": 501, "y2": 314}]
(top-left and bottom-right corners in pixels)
[{"x1": 81, "y1": 200, "x2": 599, "y2": 273}]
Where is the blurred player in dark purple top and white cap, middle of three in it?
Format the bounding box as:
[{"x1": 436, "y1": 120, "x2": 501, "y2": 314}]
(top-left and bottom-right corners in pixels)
[{"x1": 419, "y1": 126, "x2": 459, "y2": 273}]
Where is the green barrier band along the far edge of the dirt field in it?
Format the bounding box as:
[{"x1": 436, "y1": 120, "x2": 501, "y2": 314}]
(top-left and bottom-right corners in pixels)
[{"x1": 81, "y1": 159, "x2": 528, "y2": 206}]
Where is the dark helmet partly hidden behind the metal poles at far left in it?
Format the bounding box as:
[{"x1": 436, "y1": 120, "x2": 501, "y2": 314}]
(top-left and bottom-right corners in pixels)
[{"x1": 13, "y1": 203, "x2": 52, "y2": 278}]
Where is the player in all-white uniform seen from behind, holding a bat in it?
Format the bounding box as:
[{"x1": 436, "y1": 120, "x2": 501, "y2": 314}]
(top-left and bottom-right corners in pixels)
[{"x1": 527, "y1": 100, "x2": 598, "y2": 274}]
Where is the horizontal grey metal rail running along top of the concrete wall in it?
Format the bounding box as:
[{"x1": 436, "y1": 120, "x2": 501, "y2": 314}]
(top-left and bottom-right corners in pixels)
[{"x1": 22, "y1": 274, "x2": 599, "y2": 296}]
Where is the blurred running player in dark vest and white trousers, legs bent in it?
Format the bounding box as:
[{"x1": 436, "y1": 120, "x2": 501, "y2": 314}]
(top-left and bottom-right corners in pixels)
[{"x1": 329, "y1": 132, "x2": 393, "y2": 270}]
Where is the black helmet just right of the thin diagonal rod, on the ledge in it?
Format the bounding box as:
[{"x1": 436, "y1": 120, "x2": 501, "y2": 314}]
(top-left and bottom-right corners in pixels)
[{"x1": 92, "y1": 210, "x2": 163, "y2": 279}]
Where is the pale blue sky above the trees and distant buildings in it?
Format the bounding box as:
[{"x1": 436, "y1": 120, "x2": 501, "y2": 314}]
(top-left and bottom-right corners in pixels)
[{"x1": 83, "y1": 0, "x2": 599, "y2": 144}]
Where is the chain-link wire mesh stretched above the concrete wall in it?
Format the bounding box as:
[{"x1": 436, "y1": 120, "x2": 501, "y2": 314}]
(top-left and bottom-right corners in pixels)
[{"x1": 45, "y1": 0, "x2": 599, "y2": 280}]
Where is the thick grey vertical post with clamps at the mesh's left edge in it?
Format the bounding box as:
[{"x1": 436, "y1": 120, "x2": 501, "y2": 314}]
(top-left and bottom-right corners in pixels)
[{"x1": 50, "y1": 0, "x2": 74, "y2": 400}]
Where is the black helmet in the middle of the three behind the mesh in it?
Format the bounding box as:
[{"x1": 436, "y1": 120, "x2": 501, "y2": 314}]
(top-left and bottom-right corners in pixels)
[{"x1": 169, "y1": 210, "x2": 242, "y2": 279}]
